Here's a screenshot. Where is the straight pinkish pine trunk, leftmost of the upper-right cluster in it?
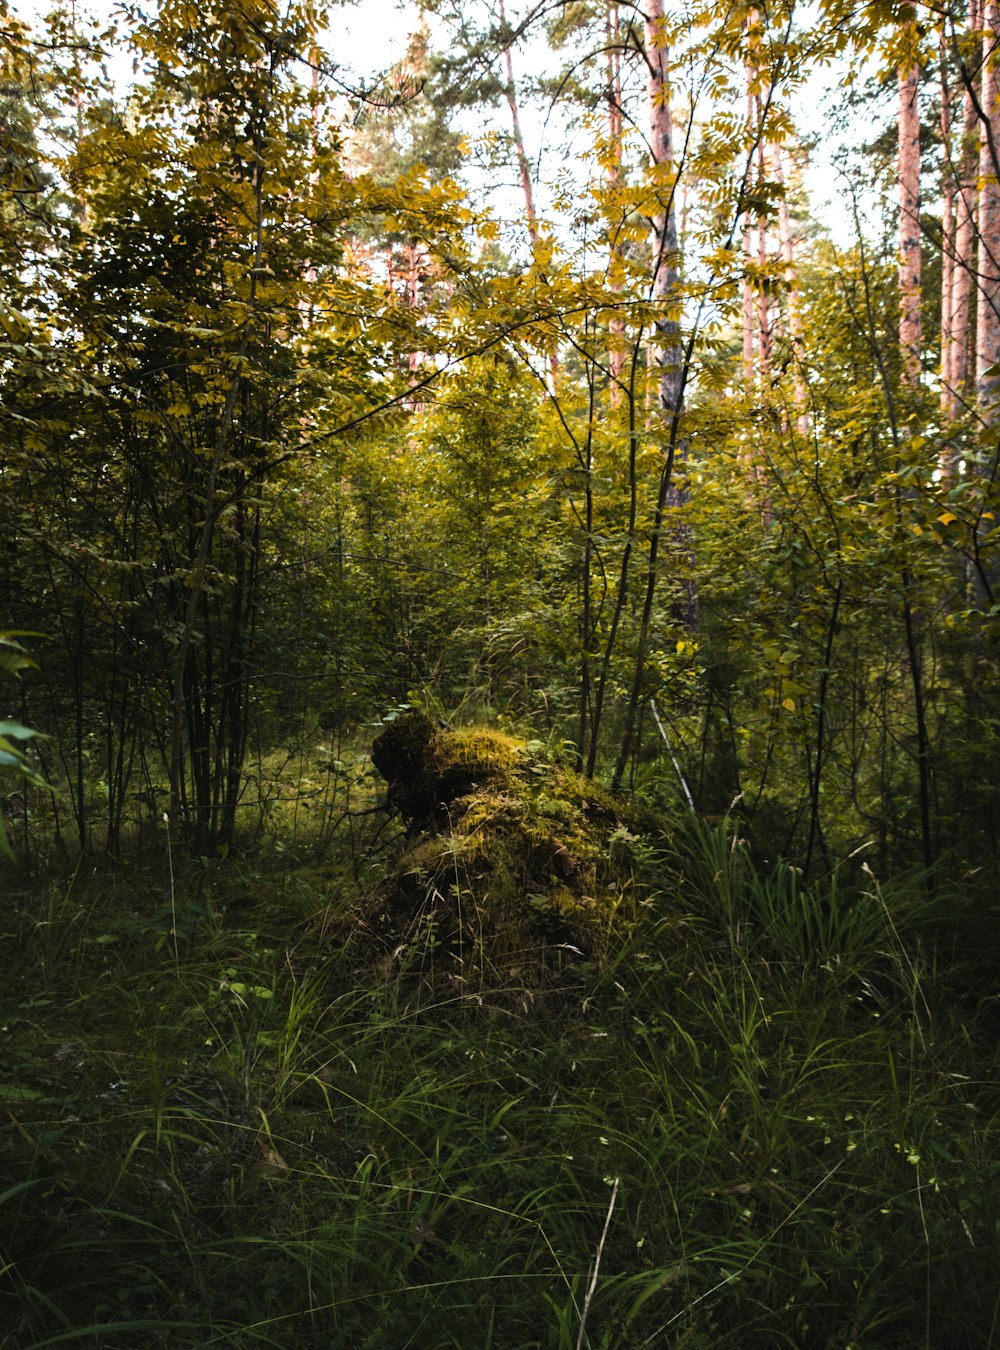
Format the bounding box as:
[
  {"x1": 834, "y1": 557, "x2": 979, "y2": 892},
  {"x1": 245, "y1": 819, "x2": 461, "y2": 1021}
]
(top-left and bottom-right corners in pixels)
[{"x1": 899, "y1": 35, "x2": 920, "y2": 387}]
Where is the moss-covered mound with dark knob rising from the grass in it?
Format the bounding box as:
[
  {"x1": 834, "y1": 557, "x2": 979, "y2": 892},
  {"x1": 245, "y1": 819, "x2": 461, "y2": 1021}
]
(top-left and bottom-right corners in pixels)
[{"x1": 362, "y1": 713, "x2": 634, "y2": 988}]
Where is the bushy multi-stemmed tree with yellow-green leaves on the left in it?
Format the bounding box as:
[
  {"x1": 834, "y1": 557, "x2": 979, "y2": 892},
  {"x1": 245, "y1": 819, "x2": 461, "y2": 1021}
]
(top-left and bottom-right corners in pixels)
[{"x1": 4, "y1": 0, "x2": 475, "y2": 849}]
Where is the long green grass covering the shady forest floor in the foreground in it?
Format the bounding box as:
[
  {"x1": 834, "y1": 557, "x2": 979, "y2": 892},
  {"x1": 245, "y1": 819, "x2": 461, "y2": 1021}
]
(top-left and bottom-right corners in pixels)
[{"x1": 0, "y1": 804, "x2": 1000, "y2": 1350}]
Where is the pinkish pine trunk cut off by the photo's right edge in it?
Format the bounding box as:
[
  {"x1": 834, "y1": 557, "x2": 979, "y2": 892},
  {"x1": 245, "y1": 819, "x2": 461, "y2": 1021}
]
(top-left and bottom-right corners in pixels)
[{"x1": 976, "y1": 0, "x2": 1000, "y2": 410}]
